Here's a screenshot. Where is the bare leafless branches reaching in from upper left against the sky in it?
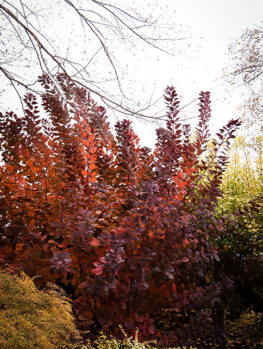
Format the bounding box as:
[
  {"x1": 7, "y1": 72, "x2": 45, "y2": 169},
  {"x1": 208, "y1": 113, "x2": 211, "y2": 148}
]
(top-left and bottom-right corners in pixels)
[{"x1": 0, "y1": 0, "x2": 184, "y2": 120}]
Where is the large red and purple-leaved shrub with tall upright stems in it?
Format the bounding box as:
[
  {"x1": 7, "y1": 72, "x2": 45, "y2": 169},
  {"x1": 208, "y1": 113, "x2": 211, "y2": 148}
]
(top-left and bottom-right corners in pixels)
[{"x1": 0, "y1": 75, "x2": 242, "y2": 346}]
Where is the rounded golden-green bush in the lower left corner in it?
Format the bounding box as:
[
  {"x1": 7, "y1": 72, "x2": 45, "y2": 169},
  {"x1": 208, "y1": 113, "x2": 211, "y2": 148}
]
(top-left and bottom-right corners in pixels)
[{"x1": 0, "y1": 271, "x2": 79, "y2": 349}]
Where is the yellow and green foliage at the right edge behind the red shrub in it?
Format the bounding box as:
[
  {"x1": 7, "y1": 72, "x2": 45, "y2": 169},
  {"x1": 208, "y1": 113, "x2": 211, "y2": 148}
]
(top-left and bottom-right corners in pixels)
[{"x1": 218, "y1": 136, "x2": 263, "y2": 260}]
